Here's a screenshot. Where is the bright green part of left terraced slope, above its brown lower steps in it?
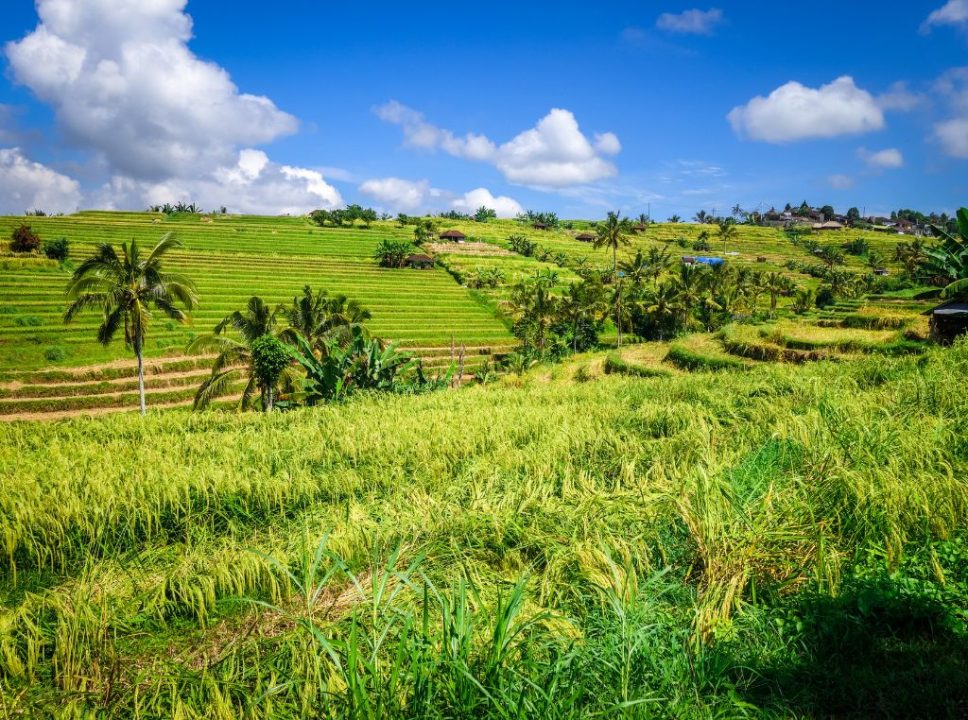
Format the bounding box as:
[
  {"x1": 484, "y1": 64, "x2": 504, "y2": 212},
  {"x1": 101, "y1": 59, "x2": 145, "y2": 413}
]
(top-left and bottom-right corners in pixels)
[{"x1": 0, "y1": 212, "x2": 510, "y2": 370}]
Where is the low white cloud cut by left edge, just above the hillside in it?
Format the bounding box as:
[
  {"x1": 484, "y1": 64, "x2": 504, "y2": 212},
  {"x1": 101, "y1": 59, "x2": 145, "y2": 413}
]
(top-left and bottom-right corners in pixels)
[{"x1": 0, "y1": 148, "x2": 81, "y2": 215}]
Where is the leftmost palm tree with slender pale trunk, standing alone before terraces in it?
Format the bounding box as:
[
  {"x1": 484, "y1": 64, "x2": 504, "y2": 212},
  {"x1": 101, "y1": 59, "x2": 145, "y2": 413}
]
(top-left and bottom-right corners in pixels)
[{"x1": 64, "y1": 233, "x2": 198, "y2": 415}]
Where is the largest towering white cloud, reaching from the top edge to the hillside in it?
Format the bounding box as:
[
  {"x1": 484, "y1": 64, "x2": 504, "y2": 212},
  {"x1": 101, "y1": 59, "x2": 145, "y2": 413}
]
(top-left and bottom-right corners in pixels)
[{"x1": 5, "y1": 0, "x2": 341, "y2": 213}]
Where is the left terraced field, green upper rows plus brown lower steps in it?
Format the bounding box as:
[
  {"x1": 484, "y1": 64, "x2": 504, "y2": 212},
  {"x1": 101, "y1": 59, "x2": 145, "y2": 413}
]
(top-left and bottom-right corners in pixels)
[{"x1": 0, "y1": 212, "x2": 513, "y2": 417}]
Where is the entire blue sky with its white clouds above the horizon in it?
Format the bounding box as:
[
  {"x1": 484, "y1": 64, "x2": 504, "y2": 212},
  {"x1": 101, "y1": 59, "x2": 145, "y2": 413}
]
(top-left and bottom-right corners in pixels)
[{"x1": 0, "y1": 0, "x2": 968, "y2": 219}]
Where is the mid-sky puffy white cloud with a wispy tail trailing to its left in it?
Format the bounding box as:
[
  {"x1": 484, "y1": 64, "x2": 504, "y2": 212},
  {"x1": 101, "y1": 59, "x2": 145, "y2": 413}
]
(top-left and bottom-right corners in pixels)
[{"x1": 375, "y1": 100, "x2": 622, "y2": 188}]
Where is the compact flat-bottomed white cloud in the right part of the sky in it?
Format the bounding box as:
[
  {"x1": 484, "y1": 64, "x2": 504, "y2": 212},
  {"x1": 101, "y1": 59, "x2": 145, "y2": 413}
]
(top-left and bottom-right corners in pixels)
[{"x1": 727, "y1": 75, "x2": 884, "y2": 143}]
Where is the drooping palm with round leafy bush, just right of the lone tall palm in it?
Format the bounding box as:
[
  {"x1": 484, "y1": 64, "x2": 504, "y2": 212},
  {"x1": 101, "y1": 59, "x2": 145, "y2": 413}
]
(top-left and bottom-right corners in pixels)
[{"x1": 188, "y1": 296, "x2": 277, "y2": 410}]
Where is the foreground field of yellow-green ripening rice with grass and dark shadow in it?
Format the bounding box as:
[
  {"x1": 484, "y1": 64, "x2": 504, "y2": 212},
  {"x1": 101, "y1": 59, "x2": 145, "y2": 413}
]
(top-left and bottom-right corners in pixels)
[{"x1": 0, "y1": 337, "x2": 968, "y2": 718}]
